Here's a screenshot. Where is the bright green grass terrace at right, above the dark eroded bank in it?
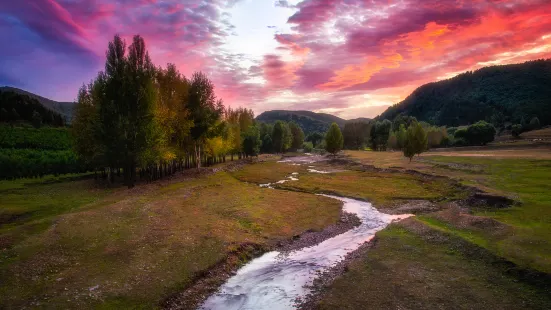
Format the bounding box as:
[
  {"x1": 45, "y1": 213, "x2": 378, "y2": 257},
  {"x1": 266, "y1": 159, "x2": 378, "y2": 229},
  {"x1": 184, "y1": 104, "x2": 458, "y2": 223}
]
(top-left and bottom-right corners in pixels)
[{"x1": 348, "y1": 148, "x2": 551, "y2": 273}]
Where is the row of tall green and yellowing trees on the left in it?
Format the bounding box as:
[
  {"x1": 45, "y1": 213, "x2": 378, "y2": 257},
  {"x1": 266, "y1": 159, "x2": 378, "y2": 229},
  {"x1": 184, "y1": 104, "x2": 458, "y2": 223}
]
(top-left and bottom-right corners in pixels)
[{"x1": 72, "y1": 35, "x2": 274, "y2": 187}]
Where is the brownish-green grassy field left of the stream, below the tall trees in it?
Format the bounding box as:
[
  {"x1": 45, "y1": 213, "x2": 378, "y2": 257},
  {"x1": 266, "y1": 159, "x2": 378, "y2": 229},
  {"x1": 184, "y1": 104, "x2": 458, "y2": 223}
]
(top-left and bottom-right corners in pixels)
[{"x1": 0, "y1": 172, "x2": 341, "y2": 309}]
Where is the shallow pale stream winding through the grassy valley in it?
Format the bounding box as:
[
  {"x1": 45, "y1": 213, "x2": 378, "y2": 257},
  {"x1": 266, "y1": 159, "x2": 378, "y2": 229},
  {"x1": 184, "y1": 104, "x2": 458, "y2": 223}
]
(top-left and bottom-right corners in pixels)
[{"x1": 200, "y1": 158, "x2": 411, "y2": 310}]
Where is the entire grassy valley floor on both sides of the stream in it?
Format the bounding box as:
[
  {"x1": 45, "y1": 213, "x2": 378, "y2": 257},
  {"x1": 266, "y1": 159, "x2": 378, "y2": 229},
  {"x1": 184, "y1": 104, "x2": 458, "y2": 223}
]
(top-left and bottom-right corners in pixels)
[{"x1": 0, "y1": 144, "x2": 551, "y2": 309}]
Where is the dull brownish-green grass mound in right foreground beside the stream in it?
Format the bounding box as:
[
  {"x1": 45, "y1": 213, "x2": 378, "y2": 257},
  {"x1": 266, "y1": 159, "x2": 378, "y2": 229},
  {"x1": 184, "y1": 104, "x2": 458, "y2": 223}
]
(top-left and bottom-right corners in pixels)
[{"x1": 312, "y1": 219, "x2": 551, "y2": 309}]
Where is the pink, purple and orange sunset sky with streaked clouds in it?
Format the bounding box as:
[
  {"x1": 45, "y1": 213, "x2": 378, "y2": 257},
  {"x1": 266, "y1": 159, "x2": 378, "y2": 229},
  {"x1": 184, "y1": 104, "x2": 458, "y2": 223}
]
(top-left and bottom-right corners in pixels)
[{"x1": 0, "y1": 0, "x2": 551, "y2": 119}]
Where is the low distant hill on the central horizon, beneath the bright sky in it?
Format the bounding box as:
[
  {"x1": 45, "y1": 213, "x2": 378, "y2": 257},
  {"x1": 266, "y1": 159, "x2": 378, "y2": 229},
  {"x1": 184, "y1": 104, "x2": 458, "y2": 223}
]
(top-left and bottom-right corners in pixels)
[{"x1": 256, "y1": 110, "x2": 369, "y2": 133}]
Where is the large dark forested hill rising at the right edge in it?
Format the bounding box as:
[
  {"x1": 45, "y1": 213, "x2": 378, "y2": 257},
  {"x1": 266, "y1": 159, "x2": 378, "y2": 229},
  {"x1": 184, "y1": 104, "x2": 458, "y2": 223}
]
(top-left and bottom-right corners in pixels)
[{"x1": 379, "y1": 59, "x2": 551, "y2": 127}]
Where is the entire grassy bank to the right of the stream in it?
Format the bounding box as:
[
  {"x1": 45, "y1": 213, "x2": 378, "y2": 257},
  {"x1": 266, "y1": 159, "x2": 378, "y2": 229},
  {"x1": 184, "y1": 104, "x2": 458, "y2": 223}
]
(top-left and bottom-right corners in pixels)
[{"x1": 231, "y1": 149, "x2": 551, "y2": 309}]
